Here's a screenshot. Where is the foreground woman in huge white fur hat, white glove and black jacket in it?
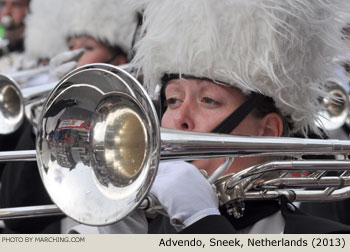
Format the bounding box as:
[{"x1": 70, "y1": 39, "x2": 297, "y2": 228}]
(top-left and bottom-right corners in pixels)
[{"x1": 82, "y1": 0, "x2": 350, "y2": 233}]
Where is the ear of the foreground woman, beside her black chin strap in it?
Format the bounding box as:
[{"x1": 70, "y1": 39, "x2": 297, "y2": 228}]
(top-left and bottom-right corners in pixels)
[{"x1": 258, "y1": 113, "x2": 283, "y2": 137}]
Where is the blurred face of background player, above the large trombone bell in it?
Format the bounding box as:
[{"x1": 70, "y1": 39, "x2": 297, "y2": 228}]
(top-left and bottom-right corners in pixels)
[{"x1": 68, "y1": 36, "x2": 126, "y2": 66}]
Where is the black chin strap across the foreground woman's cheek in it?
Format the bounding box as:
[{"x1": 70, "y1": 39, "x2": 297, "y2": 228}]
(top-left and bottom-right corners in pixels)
[{"x1": 211, "y1": 93, "x2": 265, "y2": 134}]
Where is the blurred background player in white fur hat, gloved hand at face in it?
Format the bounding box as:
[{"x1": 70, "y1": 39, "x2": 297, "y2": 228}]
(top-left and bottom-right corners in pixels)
[{"x1": 50, "y1": 0, "x2": 138, "y2": 80}]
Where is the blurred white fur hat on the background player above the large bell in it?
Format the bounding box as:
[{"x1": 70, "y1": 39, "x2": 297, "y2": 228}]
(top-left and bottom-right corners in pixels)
[{"x1": 60, "y1": 0, "x2": 138, "y2": 53}]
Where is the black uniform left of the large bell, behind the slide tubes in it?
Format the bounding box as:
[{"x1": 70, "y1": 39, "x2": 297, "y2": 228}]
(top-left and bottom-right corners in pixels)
[{"x1": 0, "y1": 122, "x2": 62, "y2": 233}]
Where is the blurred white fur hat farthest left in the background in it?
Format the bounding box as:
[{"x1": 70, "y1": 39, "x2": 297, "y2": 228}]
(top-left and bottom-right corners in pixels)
[{"x1": 24, "y1": 0, "x2": 68, "y2": 60}]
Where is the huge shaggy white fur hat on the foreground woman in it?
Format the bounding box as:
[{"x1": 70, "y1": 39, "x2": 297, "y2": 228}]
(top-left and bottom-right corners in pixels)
[{"x1": 133, "y1": 0, "x2": 349, "y2": 135}]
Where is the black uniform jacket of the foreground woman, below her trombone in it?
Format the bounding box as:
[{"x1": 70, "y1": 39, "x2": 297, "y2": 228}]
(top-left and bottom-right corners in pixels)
[{"x1": 149, "y1": 197, "x2": 350, "y2": 234}]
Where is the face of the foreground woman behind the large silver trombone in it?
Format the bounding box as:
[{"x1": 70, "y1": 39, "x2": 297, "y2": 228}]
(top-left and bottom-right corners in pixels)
[{"x1": 162, "y1": 79, "x2": 282, "y2": 174}]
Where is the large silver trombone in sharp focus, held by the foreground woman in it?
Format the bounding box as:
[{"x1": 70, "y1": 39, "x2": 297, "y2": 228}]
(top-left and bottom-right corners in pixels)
[{"x1": 0, "y1": 64, "x2": 350, "y2": 225}]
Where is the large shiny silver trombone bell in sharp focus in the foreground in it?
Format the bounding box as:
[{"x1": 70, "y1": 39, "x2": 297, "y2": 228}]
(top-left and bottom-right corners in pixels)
[{"x1": 36, "y1": 64, "x2": 160, "y2": 225}]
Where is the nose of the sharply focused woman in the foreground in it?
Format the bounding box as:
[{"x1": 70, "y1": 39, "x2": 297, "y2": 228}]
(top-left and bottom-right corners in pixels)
[{"x1": 174, "y1": 101, "x2": 195, "y2": 131}]
